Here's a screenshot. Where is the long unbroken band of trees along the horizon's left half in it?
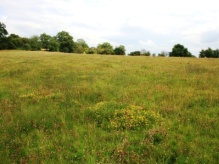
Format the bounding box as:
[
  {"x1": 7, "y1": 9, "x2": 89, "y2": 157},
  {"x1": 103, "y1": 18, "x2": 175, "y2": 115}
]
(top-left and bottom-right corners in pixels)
[{"x1": 0, "y1": 22, "x2": 126, "y2": 55}]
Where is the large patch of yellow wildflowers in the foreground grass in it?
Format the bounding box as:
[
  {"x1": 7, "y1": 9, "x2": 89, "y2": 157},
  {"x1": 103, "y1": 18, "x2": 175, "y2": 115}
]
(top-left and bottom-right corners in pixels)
[{"x1": 85, "y1": 101, "x2": 162, "y2": 130}]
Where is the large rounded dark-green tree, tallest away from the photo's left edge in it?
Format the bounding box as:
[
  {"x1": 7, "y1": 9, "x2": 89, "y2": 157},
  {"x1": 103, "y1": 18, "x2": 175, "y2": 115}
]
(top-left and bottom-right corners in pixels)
[{"x1": 56, "y1": 31, "x2": 74, "y2": 53}]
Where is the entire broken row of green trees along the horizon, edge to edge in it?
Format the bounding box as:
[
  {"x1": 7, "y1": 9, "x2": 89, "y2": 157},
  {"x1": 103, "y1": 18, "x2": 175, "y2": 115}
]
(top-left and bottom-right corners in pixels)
[{"x1": 0, "y1": 22, "x2": 219, "y2": 58}]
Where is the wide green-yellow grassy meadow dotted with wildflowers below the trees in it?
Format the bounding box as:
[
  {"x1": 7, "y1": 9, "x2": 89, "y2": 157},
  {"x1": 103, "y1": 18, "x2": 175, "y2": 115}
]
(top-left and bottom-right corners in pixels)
[{"x1": 0, "y1": 51, "x2": 219, "y2": 164}]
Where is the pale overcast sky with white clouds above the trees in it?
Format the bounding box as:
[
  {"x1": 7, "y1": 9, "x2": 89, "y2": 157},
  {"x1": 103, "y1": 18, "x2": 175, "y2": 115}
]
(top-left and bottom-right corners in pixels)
[{"x1": 0, "y1": 0, "x2": 219, "y2": 56}]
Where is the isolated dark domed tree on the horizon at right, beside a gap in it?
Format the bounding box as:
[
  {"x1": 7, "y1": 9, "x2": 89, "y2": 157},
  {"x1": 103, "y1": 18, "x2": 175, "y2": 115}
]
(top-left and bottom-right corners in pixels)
[{"x1": 169, "y1": 44, "x2": 192, "y2": 57}]
